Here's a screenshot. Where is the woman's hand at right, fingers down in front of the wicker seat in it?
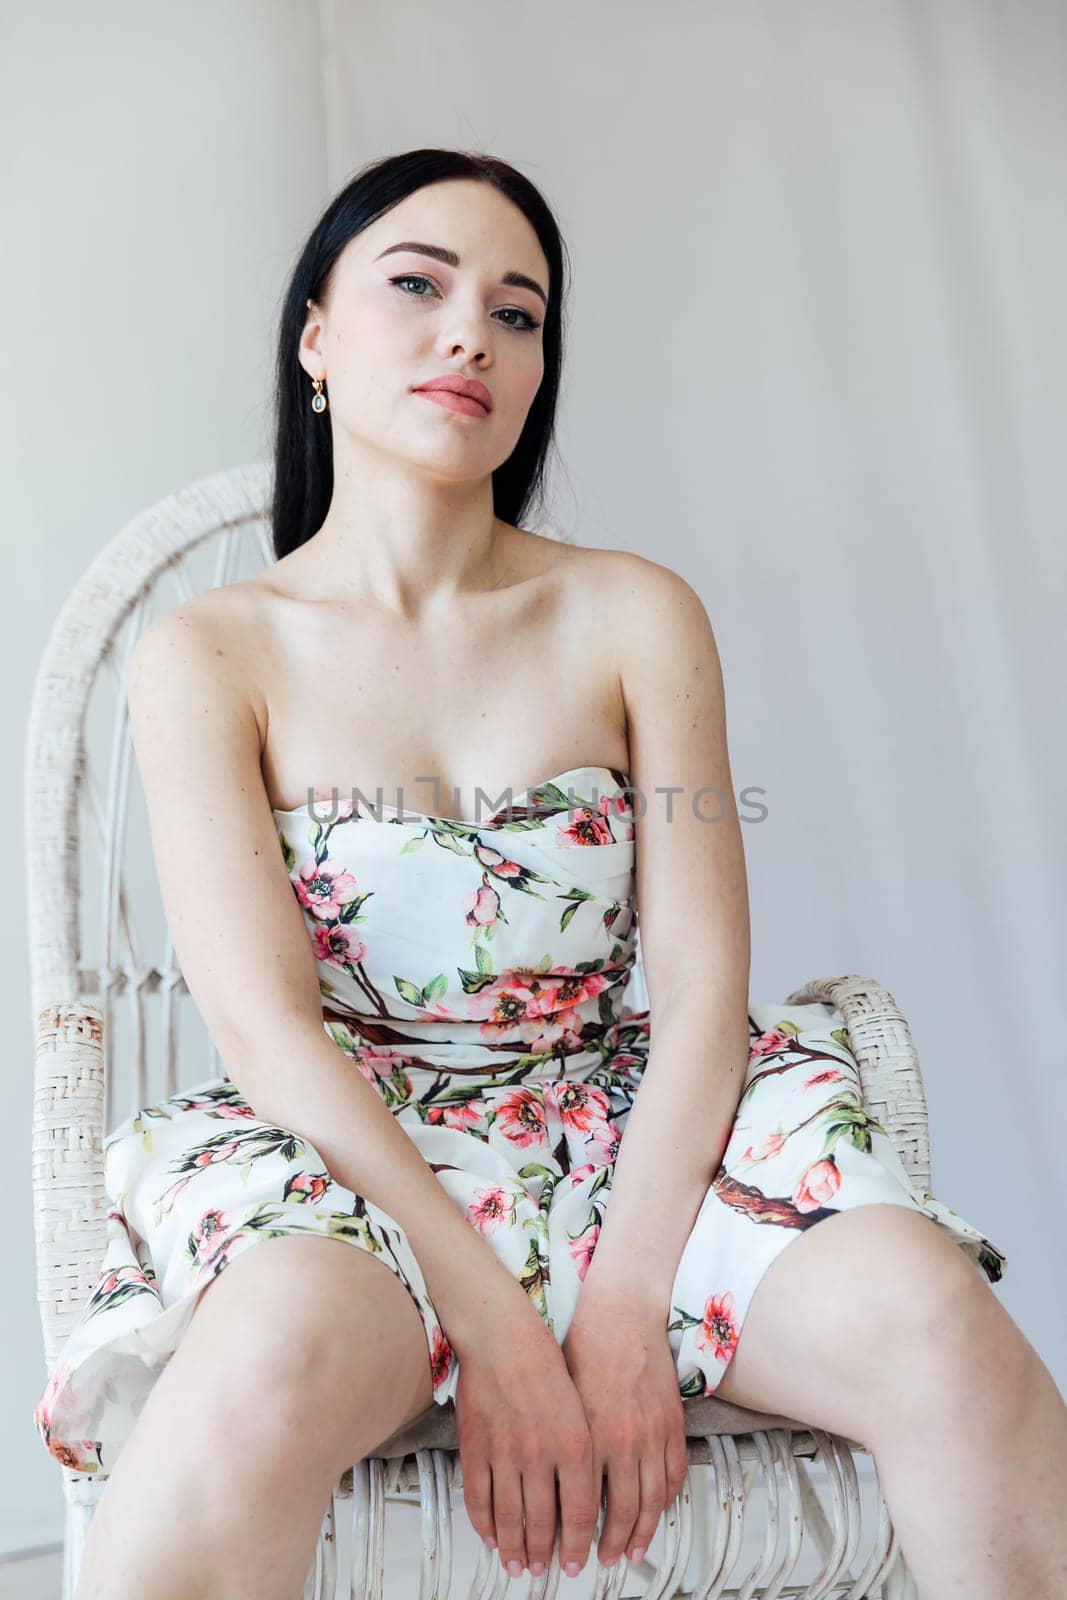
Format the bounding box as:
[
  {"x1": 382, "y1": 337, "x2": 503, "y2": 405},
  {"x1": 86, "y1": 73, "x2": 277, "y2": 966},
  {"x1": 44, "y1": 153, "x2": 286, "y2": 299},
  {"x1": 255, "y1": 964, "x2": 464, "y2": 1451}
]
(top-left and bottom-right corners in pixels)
[{"x1": 563, "y1": 1285, "x2": 688, "y2": 1566}]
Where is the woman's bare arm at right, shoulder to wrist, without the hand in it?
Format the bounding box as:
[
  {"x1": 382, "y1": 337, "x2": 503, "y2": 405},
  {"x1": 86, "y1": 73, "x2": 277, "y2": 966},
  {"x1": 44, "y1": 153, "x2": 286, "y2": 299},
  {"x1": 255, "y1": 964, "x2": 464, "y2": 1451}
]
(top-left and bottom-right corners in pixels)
[{"x1": 582, "y1": 555, "x2": 750, "y2": 1312}]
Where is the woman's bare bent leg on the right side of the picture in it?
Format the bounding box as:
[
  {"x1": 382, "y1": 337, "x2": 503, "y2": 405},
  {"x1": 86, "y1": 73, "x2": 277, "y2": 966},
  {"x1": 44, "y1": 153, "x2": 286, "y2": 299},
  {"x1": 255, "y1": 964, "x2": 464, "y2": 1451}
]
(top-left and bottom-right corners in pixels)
[{"x1": 715, "y1": 1205, "x2": 1067, "y2": 1600}]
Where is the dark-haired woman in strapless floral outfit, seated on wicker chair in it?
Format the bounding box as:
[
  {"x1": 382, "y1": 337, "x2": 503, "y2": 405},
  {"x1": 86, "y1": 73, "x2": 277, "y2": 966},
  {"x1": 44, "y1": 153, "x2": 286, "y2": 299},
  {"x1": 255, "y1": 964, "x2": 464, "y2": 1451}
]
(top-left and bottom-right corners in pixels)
[{"x1": 35, "y1": 150, "x2": 1067, "y2": 1600}]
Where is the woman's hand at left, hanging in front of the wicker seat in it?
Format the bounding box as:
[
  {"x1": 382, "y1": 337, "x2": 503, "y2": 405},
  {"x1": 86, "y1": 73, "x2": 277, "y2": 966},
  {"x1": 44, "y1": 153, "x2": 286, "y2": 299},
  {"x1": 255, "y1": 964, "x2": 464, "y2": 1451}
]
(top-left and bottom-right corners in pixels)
[{"x1": 456, "y1": 1285, "x2": 600, "y2": 1578}]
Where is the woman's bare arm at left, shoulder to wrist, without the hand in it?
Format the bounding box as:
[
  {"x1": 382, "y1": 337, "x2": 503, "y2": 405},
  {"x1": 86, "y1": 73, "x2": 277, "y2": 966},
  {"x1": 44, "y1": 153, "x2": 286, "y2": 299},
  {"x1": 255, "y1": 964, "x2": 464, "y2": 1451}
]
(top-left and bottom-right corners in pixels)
[{"x1": 126, "y1": 592, "x2": 530, "y2": 1360}]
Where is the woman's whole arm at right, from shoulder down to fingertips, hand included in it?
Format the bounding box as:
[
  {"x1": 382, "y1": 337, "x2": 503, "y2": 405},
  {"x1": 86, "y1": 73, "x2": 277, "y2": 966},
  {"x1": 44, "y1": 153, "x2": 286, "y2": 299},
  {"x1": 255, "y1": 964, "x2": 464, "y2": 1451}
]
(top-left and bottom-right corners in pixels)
[{"x1": 563, "y1": 555, "x2": 749, "y2": 1565}]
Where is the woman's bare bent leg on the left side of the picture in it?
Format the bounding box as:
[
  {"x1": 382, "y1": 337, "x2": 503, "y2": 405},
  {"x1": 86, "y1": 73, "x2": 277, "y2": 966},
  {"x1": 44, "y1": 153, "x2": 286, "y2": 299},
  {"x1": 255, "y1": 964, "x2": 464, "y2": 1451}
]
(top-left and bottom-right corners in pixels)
[{"x1": 77, "y1": 1235, "x2": 434, "y2": 1600}]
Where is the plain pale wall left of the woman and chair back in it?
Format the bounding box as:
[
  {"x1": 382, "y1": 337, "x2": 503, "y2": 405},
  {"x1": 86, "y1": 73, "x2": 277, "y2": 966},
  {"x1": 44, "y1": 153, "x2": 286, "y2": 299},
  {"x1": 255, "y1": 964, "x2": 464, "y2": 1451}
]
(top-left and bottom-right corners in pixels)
[{"x1": 0, "y1": 0, "x2": 328, "y2": 1557}]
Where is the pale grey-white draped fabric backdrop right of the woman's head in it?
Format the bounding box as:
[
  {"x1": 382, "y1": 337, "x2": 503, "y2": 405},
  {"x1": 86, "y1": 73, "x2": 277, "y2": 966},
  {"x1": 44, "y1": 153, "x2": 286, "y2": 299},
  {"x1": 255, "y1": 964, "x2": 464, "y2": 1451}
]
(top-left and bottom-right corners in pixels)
[{"x1": 320, "y1": 0, "x2": 1067, "y2": 1386}]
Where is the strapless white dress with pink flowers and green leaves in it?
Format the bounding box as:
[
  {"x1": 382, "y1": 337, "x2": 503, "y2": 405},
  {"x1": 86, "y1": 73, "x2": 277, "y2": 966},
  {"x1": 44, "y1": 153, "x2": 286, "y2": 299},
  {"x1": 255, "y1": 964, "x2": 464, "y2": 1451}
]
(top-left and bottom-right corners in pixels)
[{"x1": 34, "y1": 766, "x2": 1005, "y2": 1472}]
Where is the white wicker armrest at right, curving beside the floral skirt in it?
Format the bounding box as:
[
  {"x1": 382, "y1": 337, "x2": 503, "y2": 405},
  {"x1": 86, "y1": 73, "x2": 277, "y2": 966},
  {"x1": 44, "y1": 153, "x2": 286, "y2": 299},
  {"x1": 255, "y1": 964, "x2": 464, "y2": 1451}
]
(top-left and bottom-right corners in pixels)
[{"x1": 785, "y1": 973, "x2": 931, "y2": 1194}]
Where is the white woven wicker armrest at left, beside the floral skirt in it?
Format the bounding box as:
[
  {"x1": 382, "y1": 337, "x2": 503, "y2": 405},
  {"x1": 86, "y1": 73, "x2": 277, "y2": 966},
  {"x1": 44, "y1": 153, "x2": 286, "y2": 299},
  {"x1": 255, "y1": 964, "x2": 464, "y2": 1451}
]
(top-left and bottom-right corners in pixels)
[{"x1": 32, "y1": 1000, "x2": 107, "y2": 1374}]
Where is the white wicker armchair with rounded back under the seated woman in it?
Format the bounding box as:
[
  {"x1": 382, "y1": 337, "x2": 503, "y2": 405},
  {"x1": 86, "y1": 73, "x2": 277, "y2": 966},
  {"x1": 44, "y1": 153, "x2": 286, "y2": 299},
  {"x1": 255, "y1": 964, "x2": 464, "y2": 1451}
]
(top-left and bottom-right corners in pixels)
[{"x1": 26, "y1": 462, "x2": 929, "y2": 1600}]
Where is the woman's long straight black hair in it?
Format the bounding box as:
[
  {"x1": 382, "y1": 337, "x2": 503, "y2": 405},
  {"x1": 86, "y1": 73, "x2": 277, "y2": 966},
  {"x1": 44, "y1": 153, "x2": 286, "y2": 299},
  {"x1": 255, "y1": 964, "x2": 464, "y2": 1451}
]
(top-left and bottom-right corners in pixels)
[{"x1": 270, "y1": 149, "x2": 566, "y2": 558}]
